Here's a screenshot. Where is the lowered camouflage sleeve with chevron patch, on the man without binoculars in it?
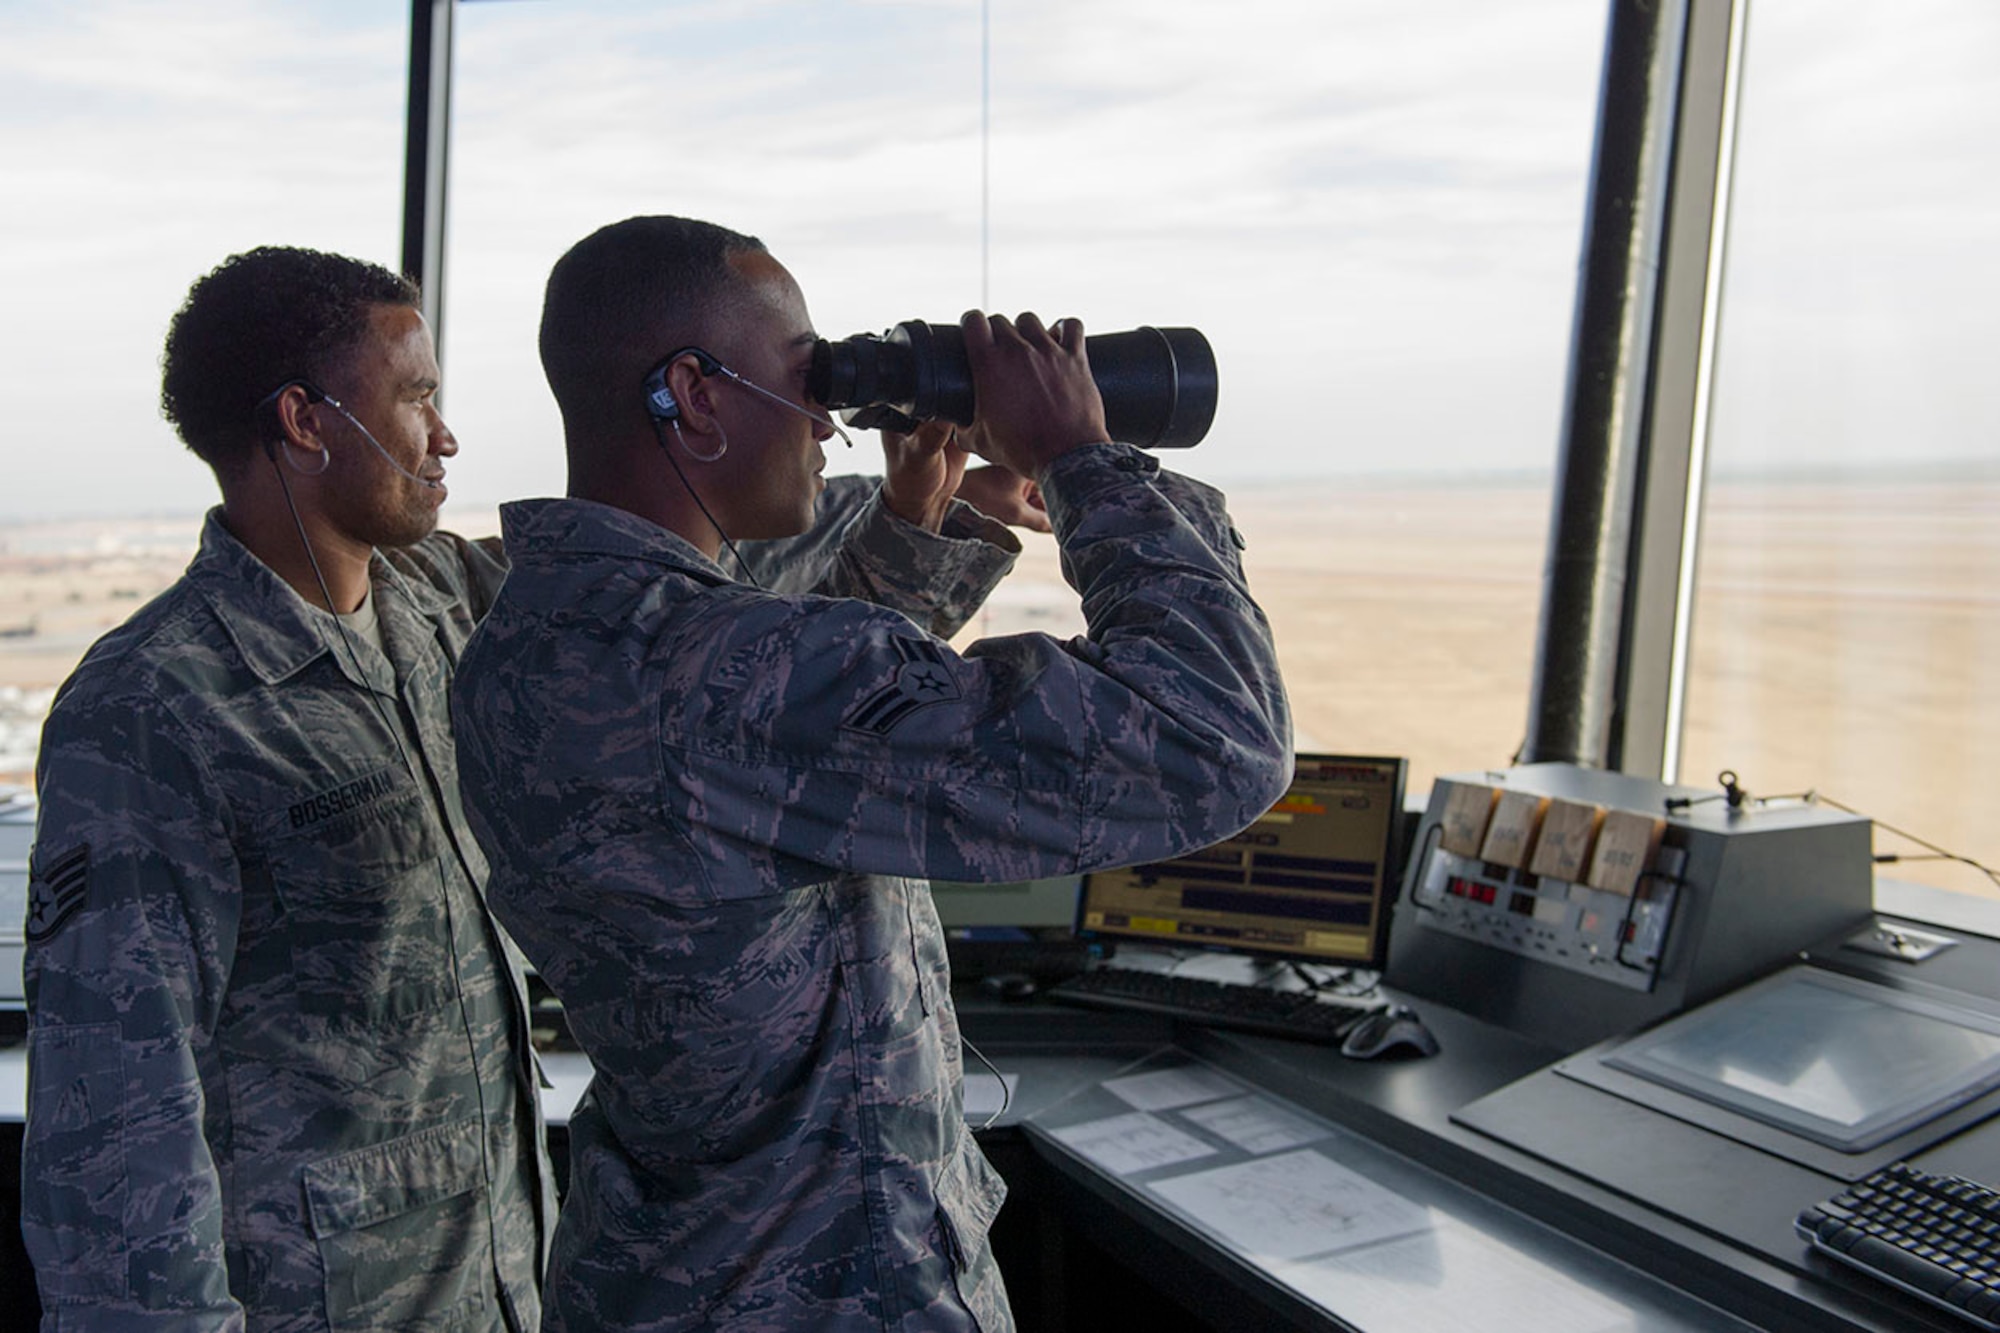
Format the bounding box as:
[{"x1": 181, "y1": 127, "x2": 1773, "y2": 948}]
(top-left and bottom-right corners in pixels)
[{"x1": 22, "y1": 689, "x2": 242, "y2": 1329}]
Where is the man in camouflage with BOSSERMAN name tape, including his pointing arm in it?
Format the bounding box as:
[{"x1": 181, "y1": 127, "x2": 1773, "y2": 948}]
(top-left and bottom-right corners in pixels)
[{"x1": 22, "y1": 248, "x2": 1020, "y2": 1333}]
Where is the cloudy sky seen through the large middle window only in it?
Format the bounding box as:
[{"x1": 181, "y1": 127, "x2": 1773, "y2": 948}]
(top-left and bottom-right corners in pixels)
[{"x1": 438, "y1": 0, "x2": 1602, "y2": 504}]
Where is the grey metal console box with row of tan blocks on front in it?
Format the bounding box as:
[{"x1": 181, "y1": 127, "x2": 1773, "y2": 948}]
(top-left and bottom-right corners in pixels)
[{"x1": 1384, "y1": 765, "x2": 1874, "y2": 1049}]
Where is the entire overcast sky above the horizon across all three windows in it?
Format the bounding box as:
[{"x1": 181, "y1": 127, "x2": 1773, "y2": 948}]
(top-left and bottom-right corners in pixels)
[{"x1": 0, "y1": 0, "x2": 2000, "y2": 520}]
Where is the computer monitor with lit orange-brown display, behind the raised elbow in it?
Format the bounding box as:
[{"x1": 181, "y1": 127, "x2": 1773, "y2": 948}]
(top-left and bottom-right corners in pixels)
[{"x1": 1076, "y1": 755, "x2": 1408, "y2": 971}]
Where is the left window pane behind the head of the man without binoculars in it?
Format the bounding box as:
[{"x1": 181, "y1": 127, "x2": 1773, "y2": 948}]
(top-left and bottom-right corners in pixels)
[{"x1": 0, "y1": 0, "x2": 410, "y2": 785}]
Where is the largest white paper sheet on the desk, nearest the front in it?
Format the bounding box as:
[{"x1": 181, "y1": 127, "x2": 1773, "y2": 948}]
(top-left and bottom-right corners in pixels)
[{"x1": 1146, "y1": 1149, "x2": 1430, "y2": 1261}]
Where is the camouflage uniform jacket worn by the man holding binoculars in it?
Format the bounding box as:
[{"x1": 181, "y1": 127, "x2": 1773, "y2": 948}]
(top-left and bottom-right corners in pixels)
[{"x1": 454, "y1": 446, "x2": 1292, "y2": 1333}]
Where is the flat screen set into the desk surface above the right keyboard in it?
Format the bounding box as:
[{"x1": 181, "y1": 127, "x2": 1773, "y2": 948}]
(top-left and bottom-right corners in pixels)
[{"x1": 1604, "y1": 967, "x2": 2000, "y2": 1153}]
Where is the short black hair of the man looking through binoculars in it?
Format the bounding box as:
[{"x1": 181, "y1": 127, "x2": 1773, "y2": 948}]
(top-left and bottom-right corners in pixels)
[{"x1": 542, "y1": 216, "x2": 764, "y2": 424}]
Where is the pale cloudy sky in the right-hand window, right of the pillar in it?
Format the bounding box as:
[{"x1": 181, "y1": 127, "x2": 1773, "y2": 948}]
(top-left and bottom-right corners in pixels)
[{"x1": 1714, "y1": 0, "x2": 2000, "y2": 470}]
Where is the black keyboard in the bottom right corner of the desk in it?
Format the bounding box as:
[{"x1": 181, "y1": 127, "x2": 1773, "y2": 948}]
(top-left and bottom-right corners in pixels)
[{"x1": 1794, "y1": 1163, "x2": 2000, "y2": 1333}]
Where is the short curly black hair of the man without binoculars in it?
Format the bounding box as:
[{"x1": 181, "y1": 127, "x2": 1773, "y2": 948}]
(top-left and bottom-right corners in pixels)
[{"x1": 160, "y1": 246, "x2": 422, "y2": 472}]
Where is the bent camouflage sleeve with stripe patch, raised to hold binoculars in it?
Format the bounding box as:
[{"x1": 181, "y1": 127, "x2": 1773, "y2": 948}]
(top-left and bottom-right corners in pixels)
[{"x1": 660, "y1": 446, "x2": 1292, "y2": 883}]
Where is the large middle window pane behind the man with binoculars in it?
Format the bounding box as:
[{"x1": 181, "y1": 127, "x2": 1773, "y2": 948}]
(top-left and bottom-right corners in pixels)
[{"x1": 446, "y1": 0, "x2": 1604, "y2": 791}]
